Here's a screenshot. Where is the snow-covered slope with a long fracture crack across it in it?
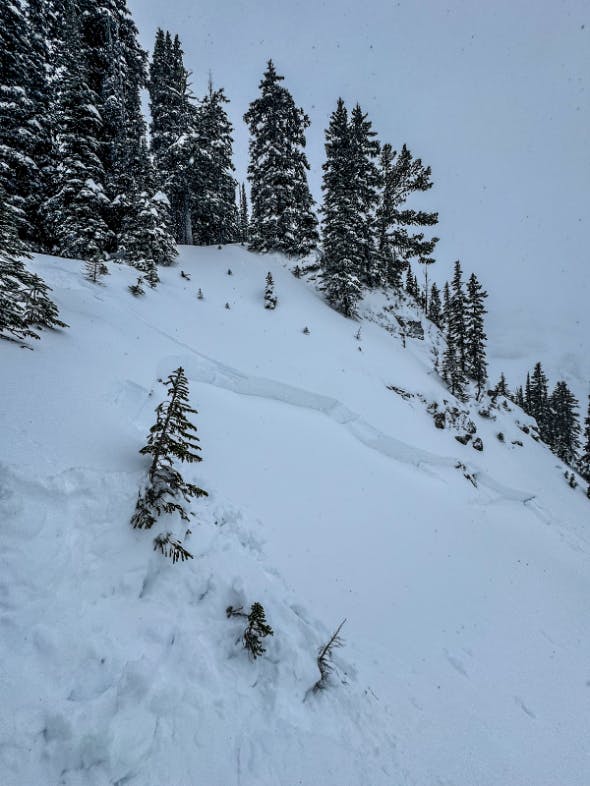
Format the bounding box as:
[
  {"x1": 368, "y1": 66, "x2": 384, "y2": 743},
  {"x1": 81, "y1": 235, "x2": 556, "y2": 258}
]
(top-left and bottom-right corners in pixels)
[{"x1": 0, "y1": 247, "x2": 590, "y2": 786}]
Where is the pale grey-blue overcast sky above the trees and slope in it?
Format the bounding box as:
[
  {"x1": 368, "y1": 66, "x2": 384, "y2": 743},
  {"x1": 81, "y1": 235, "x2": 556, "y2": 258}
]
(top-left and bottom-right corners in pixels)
[{"x1": 129, "y1": 0, "x2": 590, "y2": 395}]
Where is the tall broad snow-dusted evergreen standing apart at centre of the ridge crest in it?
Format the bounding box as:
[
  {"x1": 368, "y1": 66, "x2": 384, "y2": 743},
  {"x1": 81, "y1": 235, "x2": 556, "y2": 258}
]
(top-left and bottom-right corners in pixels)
[{"x1": 244, "y1": 60, "x2": 318, "y2": 256}]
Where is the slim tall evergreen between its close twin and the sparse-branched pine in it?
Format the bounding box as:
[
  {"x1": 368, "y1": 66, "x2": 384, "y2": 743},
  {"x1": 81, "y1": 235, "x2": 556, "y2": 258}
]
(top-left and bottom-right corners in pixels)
[{"x1": 349, "y1": 104, "x2": 381, "y2": 288}]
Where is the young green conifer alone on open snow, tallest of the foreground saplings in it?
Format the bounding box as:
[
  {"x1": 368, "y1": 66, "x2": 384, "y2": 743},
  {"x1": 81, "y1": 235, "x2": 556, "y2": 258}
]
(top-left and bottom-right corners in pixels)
[{"x1": 131, "y1": 367, "x2": 207, "y2": 529}]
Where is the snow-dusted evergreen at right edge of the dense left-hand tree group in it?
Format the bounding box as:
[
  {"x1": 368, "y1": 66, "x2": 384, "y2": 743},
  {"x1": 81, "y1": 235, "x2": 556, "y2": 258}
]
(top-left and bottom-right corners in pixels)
[{"x1": 192, "y1": 84, "x2": 238, "y2": 245}]
